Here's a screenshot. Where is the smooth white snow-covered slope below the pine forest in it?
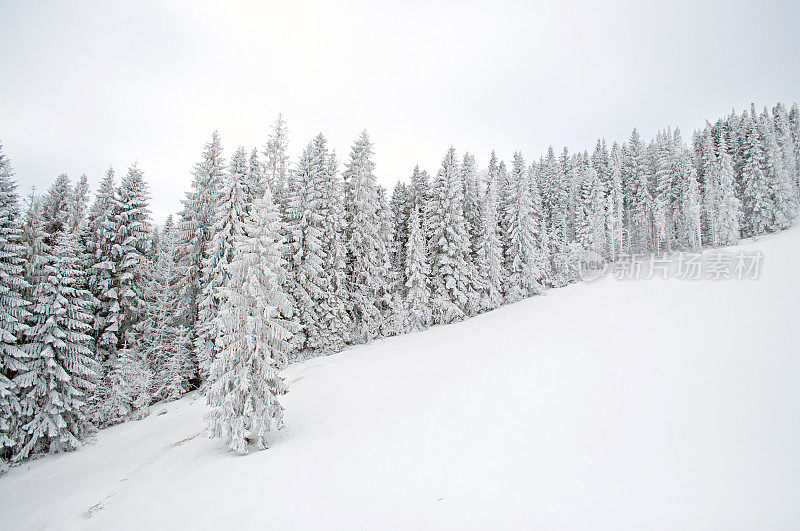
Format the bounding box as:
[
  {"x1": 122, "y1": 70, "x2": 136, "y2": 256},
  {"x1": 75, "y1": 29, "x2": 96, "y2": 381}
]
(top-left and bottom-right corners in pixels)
[{"x1": 0, "y1": 230, "x2": 800, "y2": 529}]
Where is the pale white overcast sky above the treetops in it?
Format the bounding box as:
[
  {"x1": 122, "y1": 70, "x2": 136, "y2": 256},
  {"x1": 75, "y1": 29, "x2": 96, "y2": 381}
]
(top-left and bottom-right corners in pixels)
[{"x1": 0, "y1": 0, "x2": 800, "y2": 221}]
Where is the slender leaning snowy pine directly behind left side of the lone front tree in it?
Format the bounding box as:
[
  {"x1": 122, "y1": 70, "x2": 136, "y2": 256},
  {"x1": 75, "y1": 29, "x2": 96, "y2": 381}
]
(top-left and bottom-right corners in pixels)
[{"x1": 194, "y1": 147, "x2": 250, "y2": 380}]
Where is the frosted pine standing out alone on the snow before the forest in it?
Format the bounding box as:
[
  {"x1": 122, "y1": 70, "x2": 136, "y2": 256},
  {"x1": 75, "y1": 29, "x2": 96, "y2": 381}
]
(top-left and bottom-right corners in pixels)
[{"x1": 207, "y1": 186, "x2": 292, "y2": 454}]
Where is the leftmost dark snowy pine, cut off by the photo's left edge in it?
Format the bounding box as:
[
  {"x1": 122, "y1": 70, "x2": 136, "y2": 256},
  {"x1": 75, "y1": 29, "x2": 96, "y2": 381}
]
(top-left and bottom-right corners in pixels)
[{"x1": 0, "y1": 148, "x2": 29, "y2": 468}]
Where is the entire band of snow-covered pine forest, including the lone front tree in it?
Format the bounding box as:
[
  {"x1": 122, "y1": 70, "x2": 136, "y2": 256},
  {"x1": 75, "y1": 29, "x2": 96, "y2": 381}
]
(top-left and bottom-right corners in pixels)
[{"x1": 0, "y1": 104, "x2": 800, "y2": 466}]
